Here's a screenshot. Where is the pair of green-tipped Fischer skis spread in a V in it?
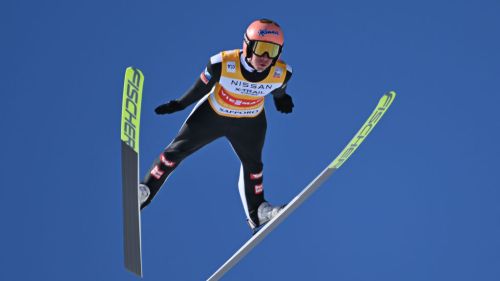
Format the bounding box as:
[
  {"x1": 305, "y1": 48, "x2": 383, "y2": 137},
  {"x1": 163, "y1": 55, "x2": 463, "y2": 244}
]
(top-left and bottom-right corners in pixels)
[{"x1": 122, "y1": 67, "x2": 396, "y2": 281}]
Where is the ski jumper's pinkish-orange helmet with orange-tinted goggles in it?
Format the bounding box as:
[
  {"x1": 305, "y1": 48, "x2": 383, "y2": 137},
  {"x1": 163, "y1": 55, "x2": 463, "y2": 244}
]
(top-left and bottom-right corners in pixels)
[{"x1": 243, "y1": 19, "x2": 284, "y2": 65}]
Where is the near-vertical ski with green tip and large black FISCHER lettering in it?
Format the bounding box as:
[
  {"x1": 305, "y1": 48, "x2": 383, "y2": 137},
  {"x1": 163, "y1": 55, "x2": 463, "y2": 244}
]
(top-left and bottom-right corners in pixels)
[{"x1": 121, "y1": 67, "x2": 144, "y2": 277}]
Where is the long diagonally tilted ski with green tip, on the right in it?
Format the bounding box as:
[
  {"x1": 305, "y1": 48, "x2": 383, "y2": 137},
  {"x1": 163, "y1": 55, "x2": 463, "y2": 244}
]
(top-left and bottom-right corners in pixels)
[{"x1": 207, "y1": 91, "x2": 396, "y2": 281}]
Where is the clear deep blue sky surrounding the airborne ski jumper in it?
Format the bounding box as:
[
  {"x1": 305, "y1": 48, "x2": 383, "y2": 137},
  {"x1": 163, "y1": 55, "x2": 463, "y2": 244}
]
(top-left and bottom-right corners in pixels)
[{"x1": 0, "y1": 0, "x2": 500, "y2": 281}]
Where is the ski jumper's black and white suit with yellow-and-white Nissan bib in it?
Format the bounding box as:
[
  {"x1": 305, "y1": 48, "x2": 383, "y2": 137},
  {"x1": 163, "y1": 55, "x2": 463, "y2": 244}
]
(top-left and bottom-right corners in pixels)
[{"x1": 141, "y1": 50, "x2": 292, "y2": 227}]
